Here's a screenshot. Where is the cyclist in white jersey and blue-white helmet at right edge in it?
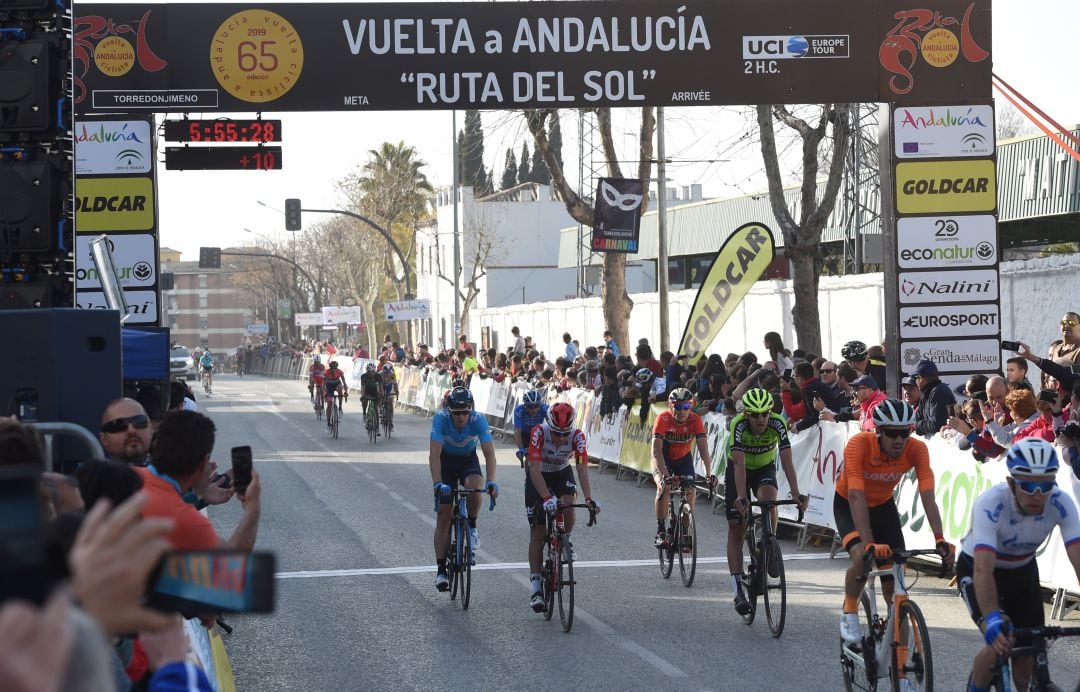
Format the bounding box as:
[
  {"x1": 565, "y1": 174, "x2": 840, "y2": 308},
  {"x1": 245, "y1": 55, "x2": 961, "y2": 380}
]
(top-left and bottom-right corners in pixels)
[{"x1": 956, "y1": 437, "x2": 1080, "y2": 692}]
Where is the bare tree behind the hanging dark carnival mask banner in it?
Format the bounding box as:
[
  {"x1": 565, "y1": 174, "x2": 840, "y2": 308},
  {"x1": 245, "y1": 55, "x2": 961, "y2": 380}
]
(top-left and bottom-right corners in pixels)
[{"x1": 525, "y1": 106, "x2": 657, "y2": 349}]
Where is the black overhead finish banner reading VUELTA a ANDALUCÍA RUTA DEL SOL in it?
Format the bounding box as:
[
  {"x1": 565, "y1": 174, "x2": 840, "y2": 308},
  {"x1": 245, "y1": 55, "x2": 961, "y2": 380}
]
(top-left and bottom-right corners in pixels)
[{"x1": 72, "y1": 0, "x2": 991, "y2": 112}]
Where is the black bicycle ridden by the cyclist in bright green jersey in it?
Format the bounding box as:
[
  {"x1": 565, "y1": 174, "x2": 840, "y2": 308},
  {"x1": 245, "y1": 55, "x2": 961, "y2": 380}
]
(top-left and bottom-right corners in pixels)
[{"x1": 741, "y1": 500, "x2": 802, "y2": 638}]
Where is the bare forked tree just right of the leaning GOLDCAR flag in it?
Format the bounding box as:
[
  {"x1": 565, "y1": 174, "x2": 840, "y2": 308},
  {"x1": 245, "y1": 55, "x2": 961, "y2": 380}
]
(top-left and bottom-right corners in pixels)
[{"x1": 757, "y1": 104, "x2": 858, "y2": 353}]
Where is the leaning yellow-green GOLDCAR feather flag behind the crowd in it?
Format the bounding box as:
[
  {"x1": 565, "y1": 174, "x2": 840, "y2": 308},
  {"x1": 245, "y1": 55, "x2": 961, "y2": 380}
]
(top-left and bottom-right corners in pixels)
[{"x1": 677, "y1": 223, "x2": 775, "y2": 363}]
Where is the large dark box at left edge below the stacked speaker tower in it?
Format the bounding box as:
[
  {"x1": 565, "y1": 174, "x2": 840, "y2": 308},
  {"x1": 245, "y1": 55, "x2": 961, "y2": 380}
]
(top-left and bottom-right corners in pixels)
[{"x1": 0, "y1": 308, "x2": 123, "y2": 469}]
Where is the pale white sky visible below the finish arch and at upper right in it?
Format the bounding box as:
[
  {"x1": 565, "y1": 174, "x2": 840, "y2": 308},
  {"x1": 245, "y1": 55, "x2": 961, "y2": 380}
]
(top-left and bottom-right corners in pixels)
[{"x1": 137, "y1": 0, "x2": 1080, "y2": 260}]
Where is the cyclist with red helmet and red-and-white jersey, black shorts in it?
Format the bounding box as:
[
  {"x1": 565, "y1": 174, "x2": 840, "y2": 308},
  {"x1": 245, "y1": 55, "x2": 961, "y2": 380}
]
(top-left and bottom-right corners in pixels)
[{"x1": 525, "y1": 403, "x2": 600, "y2": 612}]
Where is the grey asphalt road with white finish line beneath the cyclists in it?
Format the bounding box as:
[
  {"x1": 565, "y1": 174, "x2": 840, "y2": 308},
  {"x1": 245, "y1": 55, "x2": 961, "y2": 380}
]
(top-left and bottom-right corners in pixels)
[{"x1": 200, "y1": 376, "x2": 1080, "y2": 691}]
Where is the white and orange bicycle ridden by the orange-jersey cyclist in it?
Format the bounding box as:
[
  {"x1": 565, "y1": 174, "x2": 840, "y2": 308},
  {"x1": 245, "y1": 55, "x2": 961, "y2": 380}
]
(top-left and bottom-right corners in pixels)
[{"x1": 840, "y1": 548, "x2": 945, "y2": 692}]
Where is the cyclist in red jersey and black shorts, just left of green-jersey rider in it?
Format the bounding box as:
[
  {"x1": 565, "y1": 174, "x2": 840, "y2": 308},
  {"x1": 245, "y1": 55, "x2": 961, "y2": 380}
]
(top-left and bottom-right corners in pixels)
[{"x1": 652, "y1": 386, "x2": 716, "y2": 547}]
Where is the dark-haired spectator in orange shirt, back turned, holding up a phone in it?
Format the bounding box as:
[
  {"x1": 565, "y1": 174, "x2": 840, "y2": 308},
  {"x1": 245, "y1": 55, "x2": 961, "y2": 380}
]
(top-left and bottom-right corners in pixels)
[{"x1": 137, "y1": 411, "x2": 261, "y2": 552}]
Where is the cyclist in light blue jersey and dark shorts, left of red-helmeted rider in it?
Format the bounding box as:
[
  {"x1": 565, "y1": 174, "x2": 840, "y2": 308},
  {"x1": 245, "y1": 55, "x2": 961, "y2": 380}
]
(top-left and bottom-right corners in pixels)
[{"x1": 428, "y1": 386, "x2": 499, "y2": 592}]
